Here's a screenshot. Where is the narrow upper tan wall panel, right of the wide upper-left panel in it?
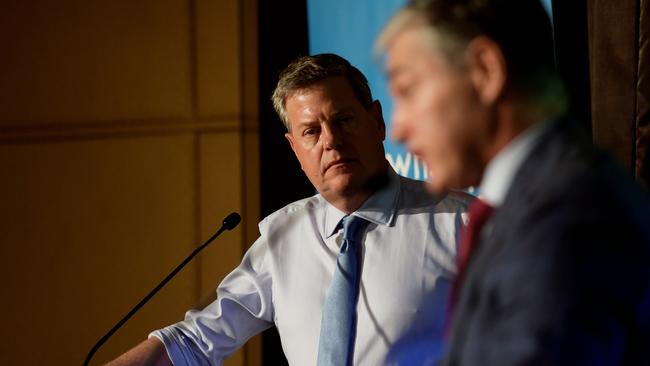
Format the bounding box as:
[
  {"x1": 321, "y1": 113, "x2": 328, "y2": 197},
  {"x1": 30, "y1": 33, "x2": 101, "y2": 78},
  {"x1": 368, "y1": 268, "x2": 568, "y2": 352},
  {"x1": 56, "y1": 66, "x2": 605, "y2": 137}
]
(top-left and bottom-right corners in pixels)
[{"x1": 196, "y1": 0, "x2": 242, "y2": 117}]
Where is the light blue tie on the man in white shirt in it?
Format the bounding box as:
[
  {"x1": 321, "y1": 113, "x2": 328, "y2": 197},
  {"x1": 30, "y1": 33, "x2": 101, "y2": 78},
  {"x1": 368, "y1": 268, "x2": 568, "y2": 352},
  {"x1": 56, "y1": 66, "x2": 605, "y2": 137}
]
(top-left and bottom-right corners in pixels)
[{"x1": 318, "y1": 216, "x2": 368, "y2": 366}]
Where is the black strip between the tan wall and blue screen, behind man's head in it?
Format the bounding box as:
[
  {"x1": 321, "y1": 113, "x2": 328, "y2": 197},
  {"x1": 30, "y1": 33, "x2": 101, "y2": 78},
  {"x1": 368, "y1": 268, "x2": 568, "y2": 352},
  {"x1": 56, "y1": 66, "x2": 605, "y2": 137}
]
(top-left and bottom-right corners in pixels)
[{"x1": 258, "y1": 0, "x2": 315, "y2": 366}]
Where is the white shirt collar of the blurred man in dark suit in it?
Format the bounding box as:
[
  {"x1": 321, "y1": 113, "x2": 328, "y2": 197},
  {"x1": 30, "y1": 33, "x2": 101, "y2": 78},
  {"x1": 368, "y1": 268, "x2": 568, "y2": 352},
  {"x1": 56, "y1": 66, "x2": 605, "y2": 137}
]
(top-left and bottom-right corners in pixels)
[{"x1": 479, "y1": 123, "x2": 549, "y2": 207}]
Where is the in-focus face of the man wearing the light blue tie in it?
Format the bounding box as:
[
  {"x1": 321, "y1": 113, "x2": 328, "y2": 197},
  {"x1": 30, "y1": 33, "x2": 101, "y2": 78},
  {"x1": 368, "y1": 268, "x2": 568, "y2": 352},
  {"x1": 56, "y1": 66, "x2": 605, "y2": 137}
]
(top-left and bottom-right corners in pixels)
[{"x1": 285, "y1": 76, "x2": 387, "y2": 207}]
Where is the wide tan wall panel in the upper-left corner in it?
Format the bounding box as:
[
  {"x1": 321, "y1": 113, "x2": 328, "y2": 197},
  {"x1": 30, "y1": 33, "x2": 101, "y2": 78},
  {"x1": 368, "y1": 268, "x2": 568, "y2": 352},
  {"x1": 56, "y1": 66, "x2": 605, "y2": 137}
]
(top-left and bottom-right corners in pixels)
[{"x1": 0, "y1": 0, "x2": 192, "y2": 126}]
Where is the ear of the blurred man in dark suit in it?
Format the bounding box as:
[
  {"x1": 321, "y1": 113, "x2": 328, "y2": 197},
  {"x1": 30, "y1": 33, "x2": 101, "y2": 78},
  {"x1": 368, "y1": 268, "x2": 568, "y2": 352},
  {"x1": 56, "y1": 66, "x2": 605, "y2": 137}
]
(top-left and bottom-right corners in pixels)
[{"x1": 465, "y1": 36, "x2": 508, "y2": 105}]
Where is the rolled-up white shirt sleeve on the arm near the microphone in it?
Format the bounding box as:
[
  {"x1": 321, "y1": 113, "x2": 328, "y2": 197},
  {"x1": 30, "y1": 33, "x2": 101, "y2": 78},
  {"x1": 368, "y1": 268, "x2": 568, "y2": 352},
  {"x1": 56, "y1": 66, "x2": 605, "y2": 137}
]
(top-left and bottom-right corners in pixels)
[{"x1": 149, "y1": 238, "x2": 273, "y2": 365}]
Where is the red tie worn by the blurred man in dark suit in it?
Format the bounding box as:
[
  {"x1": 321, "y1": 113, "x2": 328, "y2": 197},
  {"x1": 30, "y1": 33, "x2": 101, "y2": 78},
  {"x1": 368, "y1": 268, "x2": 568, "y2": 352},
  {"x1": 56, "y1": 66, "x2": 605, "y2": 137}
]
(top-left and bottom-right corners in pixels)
[{"x1": 447, "y1": 199, "x2": 494, "y2": 330}]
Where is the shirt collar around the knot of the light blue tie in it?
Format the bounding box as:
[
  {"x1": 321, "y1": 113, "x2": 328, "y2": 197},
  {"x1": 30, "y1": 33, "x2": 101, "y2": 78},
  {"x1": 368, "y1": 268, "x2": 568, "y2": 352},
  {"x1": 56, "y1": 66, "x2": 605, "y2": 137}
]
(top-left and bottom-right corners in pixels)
[{"x1": 319, "y1": 166, "x2": 400, "y2": 238}]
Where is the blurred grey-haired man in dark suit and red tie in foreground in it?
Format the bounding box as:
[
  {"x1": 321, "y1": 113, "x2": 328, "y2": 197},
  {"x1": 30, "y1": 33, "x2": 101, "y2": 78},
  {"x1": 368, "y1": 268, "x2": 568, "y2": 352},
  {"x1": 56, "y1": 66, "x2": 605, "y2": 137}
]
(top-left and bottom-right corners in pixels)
[{"x1": 379, "y1": 0, "x2": 650, "y2": 366}]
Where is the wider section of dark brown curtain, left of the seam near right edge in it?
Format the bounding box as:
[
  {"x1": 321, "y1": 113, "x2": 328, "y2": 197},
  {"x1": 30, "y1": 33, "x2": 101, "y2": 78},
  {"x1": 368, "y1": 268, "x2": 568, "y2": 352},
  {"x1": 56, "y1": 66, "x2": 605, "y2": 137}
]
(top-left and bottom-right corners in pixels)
[{"x1": 587, "y1": 0, "x2": 639, "y2": 175}]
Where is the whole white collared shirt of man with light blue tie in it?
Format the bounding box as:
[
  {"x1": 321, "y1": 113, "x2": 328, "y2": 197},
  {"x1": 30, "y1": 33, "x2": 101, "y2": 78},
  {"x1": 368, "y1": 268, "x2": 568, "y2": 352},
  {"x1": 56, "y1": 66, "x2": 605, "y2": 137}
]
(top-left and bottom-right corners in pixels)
[{"x1": 150, "y1": 168, "x2": 470, "y2": 366}]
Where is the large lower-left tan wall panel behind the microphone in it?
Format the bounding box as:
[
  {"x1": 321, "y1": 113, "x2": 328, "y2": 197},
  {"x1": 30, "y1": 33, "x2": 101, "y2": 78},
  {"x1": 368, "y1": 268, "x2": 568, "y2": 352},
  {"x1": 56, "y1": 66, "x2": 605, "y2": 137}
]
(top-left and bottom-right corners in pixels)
[{"x1": 0, "y1": 134, "x2": 197, "y2": 365}]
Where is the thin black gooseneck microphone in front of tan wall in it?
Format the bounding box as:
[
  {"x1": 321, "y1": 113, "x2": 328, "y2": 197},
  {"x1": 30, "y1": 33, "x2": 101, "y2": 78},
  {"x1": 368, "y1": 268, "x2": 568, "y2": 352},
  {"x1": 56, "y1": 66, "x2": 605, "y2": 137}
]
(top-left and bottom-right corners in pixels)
[{"x1": 84, "y1": 212, "x2": 241, "y2": 366}]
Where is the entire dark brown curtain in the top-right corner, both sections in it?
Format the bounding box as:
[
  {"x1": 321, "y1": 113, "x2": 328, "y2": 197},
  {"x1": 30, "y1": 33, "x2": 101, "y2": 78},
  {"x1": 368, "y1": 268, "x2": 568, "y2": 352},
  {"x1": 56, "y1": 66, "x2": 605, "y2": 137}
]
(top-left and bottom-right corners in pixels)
[{"x1": 587, "y1": 0, "x2": 650, "y2": 188}]
